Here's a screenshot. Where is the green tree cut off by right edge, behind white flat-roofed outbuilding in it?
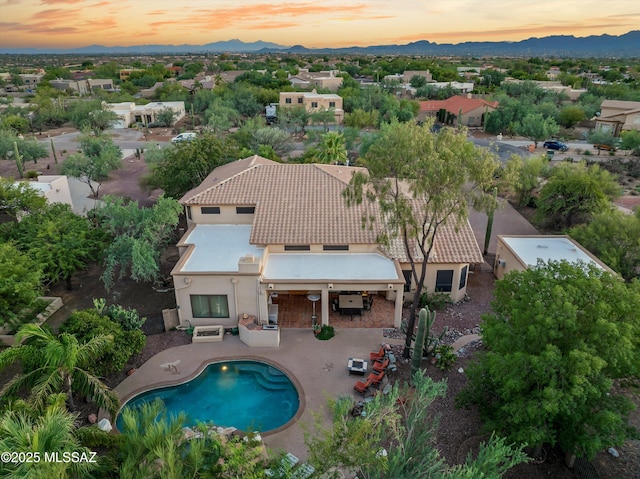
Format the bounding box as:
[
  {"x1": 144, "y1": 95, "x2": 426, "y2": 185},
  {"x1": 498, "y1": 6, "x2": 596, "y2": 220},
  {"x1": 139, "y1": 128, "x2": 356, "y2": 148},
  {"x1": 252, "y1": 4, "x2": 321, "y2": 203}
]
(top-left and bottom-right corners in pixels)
[{"x1": 569, "y1": 208, "x2": 640, "y2": 281}]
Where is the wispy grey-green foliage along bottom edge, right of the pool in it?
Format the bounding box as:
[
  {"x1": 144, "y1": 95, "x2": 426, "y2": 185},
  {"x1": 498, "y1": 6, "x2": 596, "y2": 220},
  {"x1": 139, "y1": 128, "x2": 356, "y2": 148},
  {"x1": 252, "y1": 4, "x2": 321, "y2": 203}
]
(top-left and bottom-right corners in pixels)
[{"x1": 305, "y1": 370, "x2": 526, "y2": 479}]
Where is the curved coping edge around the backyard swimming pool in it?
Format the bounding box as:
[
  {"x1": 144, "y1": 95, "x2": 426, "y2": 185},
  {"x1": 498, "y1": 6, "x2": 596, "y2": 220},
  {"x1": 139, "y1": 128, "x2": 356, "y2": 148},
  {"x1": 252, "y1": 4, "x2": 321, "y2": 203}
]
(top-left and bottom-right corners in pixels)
[{"x1": 117, "y1": 356, "x2": 307, "y2": 437}]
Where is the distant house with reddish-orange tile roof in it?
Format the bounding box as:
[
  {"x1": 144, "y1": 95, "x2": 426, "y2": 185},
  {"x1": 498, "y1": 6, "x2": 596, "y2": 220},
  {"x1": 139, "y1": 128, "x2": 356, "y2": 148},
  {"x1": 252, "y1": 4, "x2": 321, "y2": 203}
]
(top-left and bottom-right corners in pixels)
[{"x1": 418, "y1": 95, "x2": 498, "y2": 127}]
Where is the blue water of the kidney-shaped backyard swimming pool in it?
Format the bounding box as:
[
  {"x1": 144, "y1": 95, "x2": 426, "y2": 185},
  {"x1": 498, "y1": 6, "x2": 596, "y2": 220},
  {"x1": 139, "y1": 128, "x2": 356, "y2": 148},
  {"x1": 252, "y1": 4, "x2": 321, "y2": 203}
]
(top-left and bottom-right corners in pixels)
[{"x1": 116, "y1": 361, "x2": 300, "y2": 432}]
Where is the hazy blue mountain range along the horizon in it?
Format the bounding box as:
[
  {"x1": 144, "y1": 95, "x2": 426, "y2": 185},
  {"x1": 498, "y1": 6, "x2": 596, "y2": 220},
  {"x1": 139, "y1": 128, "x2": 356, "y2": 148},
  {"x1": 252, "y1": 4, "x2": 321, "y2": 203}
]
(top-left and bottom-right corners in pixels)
[{"x1": 0, "y1": 30, "x2": 640, "y2": 58}]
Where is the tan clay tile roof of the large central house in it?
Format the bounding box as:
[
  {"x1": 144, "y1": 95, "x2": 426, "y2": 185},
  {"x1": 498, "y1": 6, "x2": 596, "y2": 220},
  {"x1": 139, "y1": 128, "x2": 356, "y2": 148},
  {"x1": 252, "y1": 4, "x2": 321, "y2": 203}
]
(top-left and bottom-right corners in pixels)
[{"x1": 180, "y1": 156, "x2": 483, "y2": 263}]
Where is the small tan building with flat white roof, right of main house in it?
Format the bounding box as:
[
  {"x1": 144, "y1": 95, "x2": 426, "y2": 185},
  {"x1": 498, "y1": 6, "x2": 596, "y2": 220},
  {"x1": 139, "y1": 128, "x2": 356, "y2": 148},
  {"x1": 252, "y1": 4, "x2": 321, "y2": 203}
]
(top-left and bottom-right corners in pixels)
[{"x1": 493, "y1": 235, "x2": 615, "y2": 279}]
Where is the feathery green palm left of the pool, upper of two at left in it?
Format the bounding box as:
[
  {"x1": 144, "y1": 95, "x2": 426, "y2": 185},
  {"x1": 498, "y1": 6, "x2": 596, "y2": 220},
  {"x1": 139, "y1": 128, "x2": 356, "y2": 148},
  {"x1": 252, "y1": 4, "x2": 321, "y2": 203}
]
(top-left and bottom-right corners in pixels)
[{"x1": 0, "y1": 323, "x2": 119, "y2": 415}]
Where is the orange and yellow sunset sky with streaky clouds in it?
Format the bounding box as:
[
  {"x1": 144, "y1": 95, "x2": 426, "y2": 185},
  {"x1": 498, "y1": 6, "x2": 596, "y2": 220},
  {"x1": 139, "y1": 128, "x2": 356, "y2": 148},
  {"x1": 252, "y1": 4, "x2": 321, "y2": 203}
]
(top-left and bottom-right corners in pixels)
[{"x1": 0, "y1": 0, "x2": 640, "y2": 48}]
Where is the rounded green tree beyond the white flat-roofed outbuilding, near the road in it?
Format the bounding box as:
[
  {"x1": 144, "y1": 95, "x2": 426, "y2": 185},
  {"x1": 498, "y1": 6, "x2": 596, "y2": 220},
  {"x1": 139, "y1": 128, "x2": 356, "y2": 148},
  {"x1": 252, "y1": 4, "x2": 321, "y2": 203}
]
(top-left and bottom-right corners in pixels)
[{"x1": 535, "y1": 163, "x2": 620, "y2": 228}]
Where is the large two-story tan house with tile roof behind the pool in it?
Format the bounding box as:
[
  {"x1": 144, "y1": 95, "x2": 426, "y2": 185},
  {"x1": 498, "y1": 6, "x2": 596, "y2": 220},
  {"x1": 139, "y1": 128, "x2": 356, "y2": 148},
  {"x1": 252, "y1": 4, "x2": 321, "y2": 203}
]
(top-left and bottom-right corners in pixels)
[{"x1": 171, "y1": 156, "x2": 483, "y2": 327}]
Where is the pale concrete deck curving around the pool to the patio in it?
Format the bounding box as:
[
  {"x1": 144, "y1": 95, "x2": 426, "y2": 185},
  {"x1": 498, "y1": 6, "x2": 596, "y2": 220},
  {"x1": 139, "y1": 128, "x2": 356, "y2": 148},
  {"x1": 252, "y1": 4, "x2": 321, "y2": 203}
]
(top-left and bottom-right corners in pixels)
[{"x1": 114, "y1": 328, "x2": 403, "y2": 460}]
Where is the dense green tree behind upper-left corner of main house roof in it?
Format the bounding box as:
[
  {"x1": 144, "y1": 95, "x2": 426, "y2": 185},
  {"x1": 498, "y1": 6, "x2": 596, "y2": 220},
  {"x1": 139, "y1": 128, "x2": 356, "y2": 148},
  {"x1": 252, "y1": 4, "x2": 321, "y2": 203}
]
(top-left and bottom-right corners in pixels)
[{"x1": 145, "y1": 134, "x2": 238, "y2": 198}]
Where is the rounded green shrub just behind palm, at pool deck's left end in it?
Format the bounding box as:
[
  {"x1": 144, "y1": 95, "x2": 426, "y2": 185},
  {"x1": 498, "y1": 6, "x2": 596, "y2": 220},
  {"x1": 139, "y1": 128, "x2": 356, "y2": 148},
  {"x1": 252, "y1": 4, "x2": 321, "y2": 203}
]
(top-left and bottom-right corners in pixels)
[{"x1": 60, "y1": 309, "x2": 147, "y2": 376}]
